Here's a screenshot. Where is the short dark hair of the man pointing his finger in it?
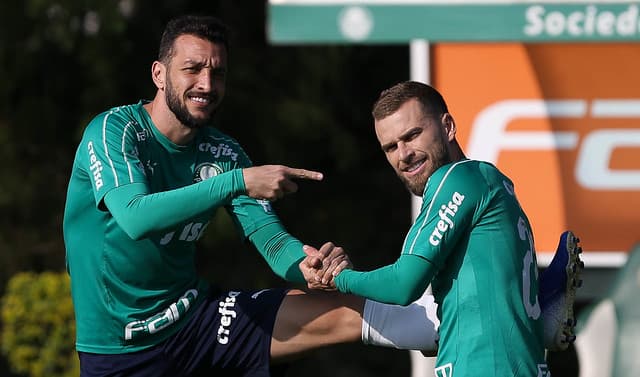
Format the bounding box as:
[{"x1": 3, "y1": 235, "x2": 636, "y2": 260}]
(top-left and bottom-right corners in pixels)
[{"x1": 158, "y1": 15, "x2": 229, "y2": 64}]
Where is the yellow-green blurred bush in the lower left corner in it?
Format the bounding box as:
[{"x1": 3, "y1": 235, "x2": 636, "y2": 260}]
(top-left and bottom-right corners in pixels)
[{"x1": 0, "y1": 272, "x2": 80, "y2": 377}]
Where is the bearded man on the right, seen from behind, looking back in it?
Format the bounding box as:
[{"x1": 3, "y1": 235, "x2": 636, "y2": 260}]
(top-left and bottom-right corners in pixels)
[{"x1": 305, "y1": 81, "x2": 582, "y2": 377}]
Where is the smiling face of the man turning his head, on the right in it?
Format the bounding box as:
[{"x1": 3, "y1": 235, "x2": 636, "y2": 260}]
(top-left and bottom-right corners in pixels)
[{"x1": 375, "y1": 98, "x2": 455, "y2": 196}]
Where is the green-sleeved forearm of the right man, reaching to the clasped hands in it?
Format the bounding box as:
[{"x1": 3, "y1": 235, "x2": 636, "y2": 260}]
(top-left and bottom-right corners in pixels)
[{"x1": 335, "y1": 254, "x2": 434, "y2": 305}]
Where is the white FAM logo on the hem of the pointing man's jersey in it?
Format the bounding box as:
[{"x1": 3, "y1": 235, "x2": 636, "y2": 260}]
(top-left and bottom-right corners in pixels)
[{"x1": 124, "y1": 289, "x2": 198, "y2": 340}]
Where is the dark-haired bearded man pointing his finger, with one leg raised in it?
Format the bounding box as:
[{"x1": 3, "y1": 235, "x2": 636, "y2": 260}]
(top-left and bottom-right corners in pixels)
[{"x1": 63, "y1": 16, "x2": 580, "y2": 376}]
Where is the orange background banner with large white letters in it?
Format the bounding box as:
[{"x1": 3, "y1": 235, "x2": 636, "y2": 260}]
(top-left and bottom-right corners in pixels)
[{"x1": 431, "y1": 43, "x2": 640, "y2": 265}]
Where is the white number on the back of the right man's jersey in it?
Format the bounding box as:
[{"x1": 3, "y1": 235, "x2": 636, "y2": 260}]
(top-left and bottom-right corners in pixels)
[{"x1": 518, "y1": 217, "x2": 540, "y2": 319}]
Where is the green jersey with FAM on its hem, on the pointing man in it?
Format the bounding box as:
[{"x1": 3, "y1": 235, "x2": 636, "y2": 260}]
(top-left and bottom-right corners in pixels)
[{"x1": 63, "y1": 101, "x2": 279, "y2": 354}]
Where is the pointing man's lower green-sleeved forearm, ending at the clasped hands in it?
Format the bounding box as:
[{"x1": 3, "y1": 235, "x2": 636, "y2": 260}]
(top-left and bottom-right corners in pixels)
[{"x1": 249, "y1": 222, "x2": 305, "y2": 283}]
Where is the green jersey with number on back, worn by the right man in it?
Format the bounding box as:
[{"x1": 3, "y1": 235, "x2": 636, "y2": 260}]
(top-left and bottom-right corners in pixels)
[{"x1": 402, "y1": 160, "x2": 547, "y2": 377}]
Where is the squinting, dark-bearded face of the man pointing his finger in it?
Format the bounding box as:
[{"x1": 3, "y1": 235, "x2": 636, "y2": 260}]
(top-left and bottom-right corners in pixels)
[{"x1": 161, "y1": 34, "x2": 227, "y2": 128}]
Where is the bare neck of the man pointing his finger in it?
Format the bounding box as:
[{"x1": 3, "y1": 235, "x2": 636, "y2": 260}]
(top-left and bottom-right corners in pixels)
[{"x1": 144, "y1": 90, "x2": 198, "y2": 145}]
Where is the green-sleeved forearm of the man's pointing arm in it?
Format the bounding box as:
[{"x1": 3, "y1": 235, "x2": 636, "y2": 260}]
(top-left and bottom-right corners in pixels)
[{"x1": 104, "y1": 169, "x2": 245, "y2": 239}]
